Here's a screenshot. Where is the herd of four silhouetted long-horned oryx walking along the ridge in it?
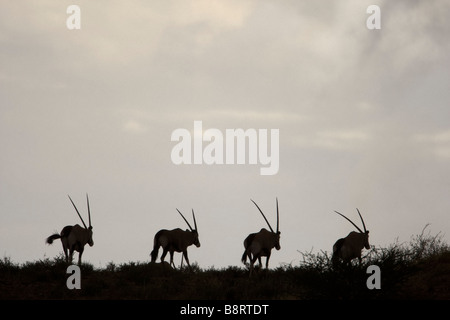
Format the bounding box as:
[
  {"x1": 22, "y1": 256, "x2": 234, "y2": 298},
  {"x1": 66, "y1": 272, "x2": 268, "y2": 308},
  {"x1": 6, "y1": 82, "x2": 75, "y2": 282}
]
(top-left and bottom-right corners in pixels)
[{"x1": 46, "y1": 194, "x2": 370, "y2": 275}]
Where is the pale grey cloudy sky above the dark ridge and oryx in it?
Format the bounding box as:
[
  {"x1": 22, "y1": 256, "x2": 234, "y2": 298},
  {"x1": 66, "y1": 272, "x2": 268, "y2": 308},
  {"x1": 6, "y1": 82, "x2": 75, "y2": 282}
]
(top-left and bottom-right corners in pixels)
[{"x1": 0, "y1": 0, "x2": 450, "y2": 267}]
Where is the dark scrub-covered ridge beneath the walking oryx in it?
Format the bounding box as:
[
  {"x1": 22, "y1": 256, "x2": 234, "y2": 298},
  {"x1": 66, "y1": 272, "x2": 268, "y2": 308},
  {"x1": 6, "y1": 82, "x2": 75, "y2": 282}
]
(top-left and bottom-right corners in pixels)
[{"x1": 0, "y1": 228, "x2": 450, "y2": 300}]
